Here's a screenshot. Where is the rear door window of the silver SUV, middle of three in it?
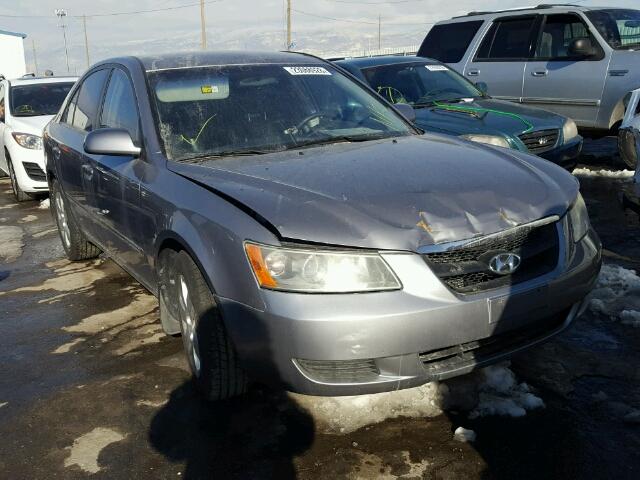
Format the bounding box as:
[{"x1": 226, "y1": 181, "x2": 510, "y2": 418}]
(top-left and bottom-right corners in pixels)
[{"x1": 476, "y1": 17, "x2": 536, "y2": 61}]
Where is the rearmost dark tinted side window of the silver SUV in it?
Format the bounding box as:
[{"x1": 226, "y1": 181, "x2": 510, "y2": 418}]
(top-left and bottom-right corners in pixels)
[{"x1": 418, "y1": 20, "x2": 483, "y2": 63}]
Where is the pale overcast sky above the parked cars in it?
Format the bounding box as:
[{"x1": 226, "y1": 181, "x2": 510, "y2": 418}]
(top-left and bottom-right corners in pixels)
[{"x1": 0, "y1": 0, "x2": 638, "y2": 73}]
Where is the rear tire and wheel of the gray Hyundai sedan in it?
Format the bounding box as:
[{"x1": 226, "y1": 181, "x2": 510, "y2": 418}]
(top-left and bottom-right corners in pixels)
[{"x1": 49, "y1": 179, "x2": 100, "y2": 261}]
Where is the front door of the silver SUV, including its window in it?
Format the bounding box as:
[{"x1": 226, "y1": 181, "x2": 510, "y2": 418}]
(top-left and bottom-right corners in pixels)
[{"x1": 522, "y1": 13, "x2": 608, "y2": 127}]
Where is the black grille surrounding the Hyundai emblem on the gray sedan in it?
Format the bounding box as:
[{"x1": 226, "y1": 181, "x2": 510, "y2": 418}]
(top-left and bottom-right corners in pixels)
[{"x1": 423, "y1": 221, "x2": 560, "y2": 294}]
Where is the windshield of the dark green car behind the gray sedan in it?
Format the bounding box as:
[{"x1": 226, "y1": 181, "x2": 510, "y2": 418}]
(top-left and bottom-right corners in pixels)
[{"x1": 362, "y1": 63, "x2": 483, "y2": 106}]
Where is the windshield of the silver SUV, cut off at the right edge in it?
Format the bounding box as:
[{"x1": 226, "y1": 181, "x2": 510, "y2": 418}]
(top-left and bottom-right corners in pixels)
[{"x1": 586, "y1": 8, "x2": 640, "y2": 50}]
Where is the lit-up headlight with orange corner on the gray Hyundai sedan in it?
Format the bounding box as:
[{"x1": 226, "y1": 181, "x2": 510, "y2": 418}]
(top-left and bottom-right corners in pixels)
[{"x1": 245, "y1": 242, "x2": 401, "y2": 293}]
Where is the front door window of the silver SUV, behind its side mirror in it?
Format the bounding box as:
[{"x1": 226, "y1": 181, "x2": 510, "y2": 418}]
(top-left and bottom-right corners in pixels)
[{"x1": 535, "y1": 14, "x2": 598, "y2": 60}]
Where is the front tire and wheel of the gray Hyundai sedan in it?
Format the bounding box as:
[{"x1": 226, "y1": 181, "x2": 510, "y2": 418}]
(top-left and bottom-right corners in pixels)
[{"x1": 169, "y1": 251, "x2": 247, "y2": 401}]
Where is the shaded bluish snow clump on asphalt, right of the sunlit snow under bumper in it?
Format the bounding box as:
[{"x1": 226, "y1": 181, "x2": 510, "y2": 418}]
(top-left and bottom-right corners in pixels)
[{"x1": 469, "y1": 363, "x2": 545, "y2": 418}]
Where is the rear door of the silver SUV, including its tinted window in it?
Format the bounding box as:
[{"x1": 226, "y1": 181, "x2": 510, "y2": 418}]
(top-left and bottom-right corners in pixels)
[{"x1": 463, "y1": 15, "x2": 540, "y2": 101}]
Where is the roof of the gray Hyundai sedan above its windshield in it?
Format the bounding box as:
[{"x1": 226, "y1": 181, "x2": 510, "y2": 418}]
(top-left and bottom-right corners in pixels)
[{"x1": 133, "y1": 50, "x2": 325, "y2": 71}]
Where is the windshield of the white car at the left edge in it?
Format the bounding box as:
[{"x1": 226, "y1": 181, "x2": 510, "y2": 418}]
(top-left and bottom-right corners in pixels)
[{"x1": 9, "y1": 82, "x2": 73, "y2": 117}]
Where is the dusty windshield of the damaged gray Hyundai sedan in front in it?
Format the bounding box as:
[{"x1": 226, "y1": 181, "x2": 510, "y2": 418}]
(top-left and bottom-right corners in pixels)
[{"x1": 147, "y1": 65, "x2": 412, "y2": 160}]
